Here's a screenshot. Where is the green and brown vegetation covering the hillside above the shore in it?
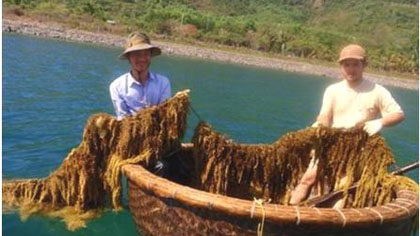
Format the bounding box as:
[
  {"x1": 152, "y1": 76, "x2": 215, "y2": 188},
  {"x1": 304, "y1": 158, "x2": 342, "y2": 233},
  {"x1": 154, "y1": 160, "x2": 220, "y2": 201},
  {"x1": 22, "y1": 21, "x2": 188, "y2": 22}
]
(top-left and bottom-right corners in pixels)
[{"x1": 3, "y1": 0, "x2": 419, "y2": 74}]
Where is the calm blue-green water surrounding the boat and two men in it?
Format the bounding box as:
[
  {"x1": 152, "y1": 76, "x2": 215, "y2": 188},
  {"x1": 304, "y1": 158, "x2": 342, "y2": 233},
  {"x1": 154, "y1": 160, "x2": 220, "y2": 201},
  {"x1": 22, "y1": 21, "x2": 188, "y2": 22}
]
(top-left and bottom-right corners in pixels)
[{"x1": 2, "y1": 34, "x2": 419, "y2": 236}]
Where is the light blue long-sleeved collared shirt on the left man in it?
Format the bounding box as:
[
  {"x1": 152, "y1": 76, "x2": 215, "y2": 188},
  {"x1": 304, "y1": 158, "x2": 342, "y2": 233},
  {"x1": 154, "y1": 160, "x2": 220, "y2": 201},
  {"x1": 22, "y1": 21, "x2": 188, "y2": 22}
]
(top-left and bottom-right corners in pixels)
[{"x1": 109, "y1": 72, "x2": 171, "y2": 120}]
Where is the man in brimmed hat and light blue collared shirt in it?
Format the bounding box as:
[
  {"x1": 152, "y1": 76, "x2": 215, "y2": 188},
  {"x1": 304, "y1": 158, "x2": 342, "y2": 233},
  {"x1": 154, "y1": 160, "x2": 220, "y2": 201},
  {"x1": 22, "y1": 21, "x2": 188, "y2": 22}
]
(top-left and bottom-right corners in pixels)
[{"x1": 109, "y1": 33, "x2": 171, "y2": 120}]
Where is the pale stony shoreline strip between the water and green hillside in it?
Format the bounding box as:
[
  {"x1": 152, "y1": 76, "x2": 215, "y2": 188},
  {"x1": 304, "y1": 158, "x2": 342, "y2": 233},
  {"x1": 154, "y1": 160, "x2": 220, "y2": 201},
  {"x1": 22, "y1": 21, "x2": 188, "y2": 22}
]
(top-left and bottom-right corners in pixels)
[{"x1": 2, "y1": 16, "x2": 419, "y2": 90}]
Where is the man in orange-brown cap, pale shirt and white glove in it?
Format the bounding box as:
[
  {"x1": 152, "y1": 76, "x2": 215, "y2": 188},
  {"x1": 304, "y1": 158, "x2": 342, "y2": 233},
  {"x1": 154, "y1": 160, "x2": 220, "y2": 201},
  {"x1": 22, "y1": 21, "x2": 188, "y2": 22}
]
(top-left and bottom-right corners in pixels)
[{"x1": 290, "y1": 44, "x2": 404, "y2": 207}]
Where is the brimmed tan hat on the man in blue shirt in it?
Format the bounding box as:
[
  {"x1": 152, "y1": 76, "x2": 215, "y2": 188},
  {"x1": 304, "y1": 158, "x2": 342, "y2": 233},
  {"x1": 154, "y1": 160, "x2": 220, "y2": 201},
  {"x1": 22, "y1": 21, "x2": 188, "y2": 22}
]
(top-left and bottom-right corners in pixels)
[{"x1": 119, "y1": 33, "x2": 161, "y2": 59}]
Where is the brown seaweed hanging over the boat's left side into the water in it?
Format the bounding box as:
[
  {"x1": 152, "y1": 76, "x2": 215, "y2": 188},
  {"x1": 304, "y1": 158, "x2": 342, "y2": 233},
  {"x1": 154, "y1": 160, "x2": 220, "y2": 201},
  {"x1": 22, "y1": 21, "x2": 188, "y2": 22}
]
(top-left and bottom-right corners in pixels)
[{"x1": 3, "y1": 90, "x2": 189, "y2": 230}]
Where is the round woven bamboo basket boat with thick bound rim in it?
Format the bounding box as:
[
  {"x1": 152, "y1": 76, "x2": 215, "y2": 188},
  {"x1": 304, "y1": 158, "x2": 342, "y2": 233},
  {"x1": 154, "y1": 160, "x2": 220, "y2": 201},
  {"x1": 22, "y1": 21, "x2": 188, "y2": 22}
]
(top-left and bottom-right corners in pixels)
[{"x1": 123, "y1": 145, "x2": 418, "y2": 236}]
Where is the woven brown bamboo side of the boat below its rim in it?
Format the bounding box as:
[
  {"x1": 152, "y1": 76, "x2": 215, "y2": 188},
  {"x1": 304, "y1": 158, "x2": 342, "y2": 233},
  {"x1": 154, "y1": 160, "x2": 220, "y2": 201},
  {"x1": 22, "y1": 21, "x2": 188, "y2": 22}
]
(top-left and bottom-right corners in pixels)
[{"x1": 129, "y1": 178, "x2": 416, "y2": 236}]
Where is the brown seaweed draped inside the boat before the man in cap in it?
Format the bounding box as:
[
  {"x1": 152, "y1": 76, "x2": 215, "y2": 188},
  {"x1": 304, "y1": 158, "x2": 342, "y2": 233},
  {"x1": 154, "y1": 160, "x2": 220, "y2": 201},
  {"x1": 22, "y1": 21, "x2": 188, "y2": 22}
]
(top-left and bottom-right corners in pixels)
[{"x1": 193, "y1": 123, "x2": 418, "y2": 207}]
